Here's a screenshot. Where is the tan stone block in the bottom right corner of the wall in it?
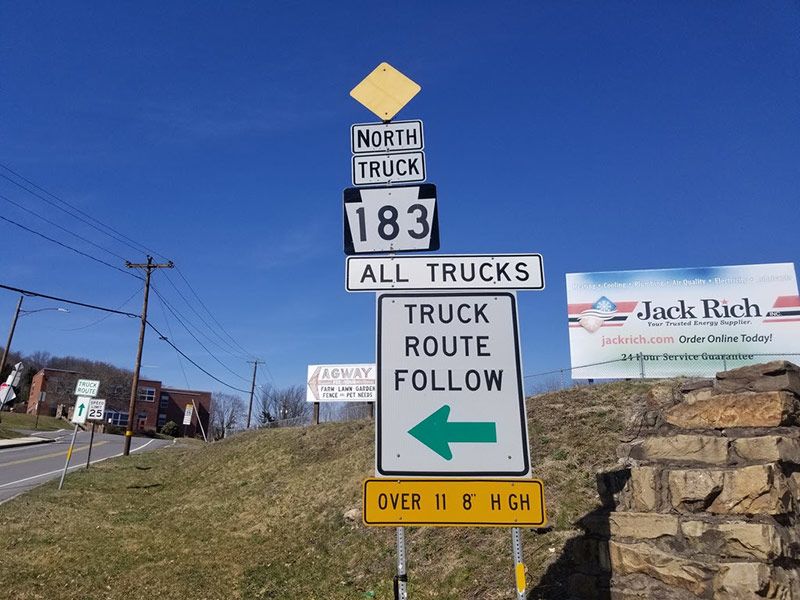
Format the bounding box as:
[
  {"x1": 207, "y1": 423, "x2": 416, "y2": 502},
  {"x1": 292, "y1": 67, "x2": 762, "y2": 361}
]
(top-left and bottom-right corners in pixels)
[{"x1": 714, "y1": 562, "x2": 800, "y2": 600}]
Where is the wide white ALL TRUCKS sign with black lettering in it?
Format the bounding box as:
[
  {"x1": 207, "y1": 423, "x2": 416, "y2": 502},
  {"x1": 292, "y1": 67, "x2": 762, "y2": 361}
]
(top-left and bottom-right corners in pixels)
[{"x1": 345, "y1": 254, "x2": 544, "y2": 292}]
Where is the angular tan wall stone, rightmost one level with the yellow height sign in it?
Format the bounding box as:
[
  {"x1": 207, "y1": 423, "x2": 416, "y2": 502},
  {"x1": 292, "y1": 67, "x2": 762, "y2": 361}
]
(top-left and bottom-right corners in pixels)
[{"x1": 708, "y1": 464, "x2": 794, "y2": 515}]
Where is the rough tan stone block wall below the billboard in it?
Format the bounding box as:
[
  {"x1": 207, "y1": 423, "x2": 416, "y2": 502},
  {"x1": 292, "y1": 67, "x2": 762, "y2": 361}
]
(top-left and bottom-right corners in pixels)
[{"x1": 571, "y1": 361, "x2": 800, "y2": 600}]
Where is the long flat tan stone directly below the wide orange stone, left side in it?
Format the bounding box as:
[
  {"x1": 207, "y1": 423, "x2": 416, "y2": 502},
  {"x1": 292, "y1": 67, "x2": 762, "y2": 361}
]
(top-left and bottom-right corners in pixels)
[{"x1": 629, "y1": 434, "x2": 728, "y2": 466}]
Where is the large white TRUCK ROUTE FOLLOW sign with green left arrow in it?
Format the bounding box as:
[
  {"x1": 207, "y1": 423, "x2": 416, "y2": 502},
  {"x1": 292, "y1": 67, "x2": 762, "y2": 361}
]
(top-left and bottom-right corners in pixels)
[{"x1": 376, "y1": 292, "x2": 530, "y2": 477}]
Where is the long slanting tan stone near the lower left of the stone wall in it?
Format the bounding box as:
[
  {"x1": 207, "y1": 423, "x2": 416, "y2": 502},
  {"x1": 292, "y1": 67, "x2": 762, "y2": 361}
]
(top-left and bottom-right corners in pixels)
[{"x1": 609, "y1": 540, "x2": 711, "y2": 596}]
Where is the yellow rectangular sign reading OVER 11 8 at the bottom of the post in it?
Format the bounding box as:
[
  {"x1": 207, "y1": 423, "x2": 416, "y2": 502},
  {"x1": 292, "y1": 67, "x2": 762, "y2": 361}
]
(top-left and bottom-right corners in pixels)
[{"x1": 363, "y1": 479, "x2": 547, "y2": 527}]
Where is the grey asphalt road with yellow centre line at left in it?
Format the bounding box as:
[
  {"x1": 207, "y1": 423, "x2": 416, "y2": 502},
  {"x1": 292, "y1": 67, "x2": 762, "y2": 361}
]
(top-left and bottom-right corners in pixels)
[{"x1": 0, "y1": 430, "x2": 172, "y2": 504}]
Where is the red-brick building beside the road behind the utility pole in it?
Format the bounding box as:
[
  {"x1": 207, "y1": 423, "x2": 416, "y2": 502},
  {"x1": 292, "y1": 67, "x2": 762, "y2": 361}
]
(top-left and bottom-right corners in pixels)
[{"x1": 27, "y1": 369, "x2": 211, "y2": 437}]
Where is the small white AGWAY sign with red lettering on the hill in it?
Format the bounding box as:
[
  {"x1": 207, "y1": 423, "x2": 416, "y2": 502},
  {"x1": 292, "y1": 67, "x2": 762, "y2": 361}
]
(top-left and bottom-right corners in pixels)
[{"x1": 306, "y1": 364, "x2": 377, "y2": 402}]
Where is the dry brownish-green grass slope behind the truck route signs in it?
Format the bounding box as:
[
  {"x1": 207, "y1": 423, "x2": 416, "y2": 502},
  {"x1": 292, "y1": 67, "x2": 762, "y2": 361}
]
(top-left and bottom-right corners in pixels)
[{"x1": 0, "y1": 382, "x2": 650, "y2": 600}]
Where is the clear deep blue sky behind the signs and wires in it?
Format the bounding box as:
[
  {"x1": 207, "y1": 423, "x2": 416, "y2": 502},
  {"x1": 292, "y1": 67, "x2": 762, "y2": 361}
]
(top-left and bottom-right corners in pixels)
[{"x1": 0, "y1": 1, "x2": 800, "y2": 390}]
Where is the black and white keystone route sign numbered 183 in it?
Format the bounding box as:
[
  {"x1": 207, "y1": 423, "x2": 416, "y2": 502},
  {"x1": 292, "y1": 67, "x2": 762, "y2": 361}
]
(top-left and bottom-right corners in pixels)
[{"x1": 344, "y1": 183, "x2": 439, "y2": 255}]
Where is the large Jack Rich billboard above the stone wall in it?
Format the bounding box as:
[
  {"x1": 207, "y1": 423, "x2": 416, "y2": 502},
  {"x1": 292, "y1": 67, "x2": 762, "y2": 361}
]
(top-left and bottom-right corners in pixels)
[{"x1": 567, "y1": 263, "x2": 800, "y2": 379}]
